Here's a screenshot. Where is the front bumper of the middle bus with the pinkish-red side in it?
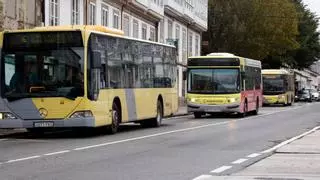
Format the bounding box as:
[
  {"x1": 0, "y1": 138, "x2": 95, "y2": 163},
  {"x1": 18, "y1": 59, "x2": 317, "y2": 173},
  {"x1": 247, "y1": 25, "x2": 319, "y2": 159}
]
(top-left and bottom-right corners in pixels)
[{"x1": 188, "y1": 102, "x2": 240, "y2": 113}]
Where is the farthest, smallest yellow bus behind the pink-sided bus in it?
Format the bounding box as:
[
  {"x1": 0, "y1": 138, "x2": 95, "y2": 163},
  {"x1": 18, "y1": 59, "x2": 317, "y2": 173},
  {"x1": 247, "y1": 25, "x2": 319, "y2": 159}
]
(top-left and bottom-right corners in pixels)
[{"x1": 262, "y1": 69, "x2": 295, "y2": 106}]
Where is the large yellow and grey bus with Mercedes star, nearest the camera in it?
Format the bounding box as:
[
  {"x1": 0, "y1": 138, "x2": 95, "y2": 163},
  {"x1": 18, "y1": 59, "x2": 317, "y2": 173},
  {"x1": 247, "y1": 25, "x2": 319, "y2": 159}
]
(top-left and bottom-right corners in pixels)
[{"x1": 0, "y1": 26, "x2": 178, "y2": 133}]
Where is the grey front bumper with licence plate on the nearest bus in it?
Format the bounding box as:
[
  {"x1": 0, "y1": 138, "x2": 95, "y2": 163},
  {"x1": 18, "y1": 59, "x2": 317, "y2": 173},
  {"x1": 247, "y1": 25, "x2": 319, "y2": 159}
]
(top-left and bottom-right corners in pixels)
[{"x1": 0, "y1": 117, "x2": 95, "y2": 129}]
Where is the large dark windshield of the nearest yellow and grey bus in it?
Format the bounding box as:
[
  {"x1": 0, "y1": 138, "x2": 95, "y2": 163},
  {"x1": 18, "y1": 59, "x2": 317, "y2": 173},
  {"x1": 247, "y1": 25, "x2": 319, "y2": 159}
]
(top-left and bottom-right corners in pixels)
[{"x1": 1, "y1": 33, "x2": 84, "y2": 101}]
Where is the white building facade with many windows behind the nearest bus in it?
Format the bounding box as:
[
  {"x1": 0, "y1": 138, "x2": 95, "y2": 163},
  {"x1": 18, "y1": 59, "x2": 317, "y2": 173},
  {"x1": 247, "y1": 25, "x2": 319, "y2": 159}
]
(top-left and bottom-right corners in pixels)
[{"x1": 44, "y1": 0, "x2": 208, "y2": 101}]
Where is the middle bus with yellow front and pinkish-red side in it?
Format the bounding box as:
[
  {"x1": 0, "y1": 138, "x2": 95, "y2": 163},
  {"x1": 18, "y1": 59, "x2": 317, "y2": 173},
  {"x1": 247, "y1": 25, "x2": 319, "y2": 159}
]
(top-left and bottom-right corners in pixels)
[{"x1": 187, "y1": 53, "x2": 262, "y2": 118}]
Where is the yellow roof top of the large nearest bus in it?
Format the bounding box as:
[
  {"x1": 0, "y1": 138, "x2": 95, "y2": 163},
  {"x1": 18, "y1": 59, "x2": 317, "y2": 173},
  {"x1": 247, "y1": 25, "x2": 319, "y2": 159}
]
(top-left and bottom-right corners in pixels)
[{"x1": 4, "y1": 25, "x2": 124, "y2": 36}]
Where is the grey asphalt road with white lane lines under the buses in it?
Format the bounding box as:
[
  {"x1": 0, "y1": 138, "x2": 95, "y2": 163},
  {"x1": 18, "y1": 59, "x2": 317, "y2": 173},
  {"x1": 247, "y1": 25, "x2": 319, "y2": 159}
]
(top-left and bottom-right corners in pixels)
[{"x1": 0, "y1": 103, "x2": 320, "y2": 180}]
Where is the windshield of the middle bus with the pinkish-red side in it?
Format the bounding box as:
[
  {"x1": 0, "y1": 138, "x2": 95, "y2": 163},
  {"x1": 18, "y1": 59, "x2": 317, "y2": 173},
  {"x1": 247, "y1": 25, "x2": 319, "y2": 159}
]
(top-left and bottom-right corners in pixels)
[{"x1": 188, "y1": 69, "x2": 240, "y2": 94}]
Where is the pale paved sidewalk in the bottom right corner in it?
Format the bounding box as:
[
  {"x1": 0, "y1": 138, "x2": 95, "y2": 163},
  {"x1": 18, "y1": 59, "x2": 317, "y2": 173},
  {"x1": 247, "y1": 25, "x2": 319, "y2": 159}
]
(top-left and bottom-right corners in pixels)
[{"x1": 203, "y1": 127, "x2": 320, "y2": 180}]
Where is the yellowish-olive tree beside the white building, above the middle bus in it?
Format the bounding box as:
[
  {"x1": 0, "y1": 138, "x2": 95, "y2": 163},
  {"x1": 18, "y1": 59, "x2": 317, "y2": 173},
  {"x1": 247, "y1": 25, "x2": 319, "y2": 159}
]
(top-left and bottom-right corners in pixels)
[{"x1": 207, "y1": 0, "x2": 299, "y2": 60}]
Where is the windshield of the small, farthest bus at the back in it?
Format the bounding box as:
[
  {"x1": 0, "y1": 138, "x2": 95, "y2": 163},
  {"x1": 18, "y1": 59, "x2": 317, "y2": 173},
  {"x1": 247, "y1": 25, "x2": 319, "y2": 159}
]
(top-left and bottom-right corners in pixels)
[{"x1": 263, "y1": 76, "x2": 285, "y2": 95}]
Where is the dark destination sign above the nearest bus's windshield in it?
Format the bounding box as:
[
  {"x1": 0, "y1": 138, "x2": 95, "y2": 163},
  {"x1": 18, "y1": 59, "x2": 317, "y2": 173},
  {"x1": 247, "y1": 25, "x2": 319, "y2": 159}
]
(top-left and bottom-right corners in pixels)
[{"x1": 3, "y1": 31, "x2": 83, "y2": 49}]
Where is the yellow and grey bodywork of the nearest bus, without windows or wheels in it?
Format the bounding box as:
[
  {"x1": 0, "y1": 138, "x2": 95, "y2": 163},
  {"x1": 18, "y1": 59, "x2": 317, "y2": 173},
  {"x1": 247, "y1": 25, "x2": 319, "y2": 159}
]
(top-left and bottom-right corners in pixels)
[{"x1": 0, "y1": 26, "x2": 178, "y2": 128}]
